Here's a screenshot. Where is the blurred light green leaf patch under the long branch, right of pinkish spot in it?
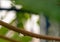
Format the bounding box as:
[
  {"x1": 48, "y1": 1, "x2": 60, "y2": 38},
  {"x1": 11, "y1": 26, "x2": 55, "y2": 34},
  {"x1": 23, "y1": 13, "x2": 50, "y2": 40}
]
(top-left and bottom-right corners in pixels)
[{"x1": 12, "y1": 33, "x2": 32, "y2": 42}]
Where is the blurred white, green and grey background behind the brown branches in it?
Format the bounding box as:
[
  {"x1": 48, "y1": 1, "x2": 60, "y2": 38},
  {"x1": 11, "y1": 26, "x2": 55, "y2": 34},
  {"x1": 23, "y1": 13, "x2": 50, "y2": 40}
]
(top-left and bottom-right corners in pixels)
[{"x1": 0, "y1": 0, "x2": 60, "y2": 42}]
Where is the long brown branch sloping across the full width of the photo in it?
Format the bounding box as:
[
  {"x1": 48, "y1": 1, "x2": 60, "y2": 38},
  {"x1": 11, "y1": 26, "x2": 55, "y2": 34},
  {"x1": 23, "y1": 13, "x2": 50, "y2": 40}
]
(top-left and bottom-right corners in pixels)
[{"x1": 0, "y1": 21, "x2": 60, "y2": 41}]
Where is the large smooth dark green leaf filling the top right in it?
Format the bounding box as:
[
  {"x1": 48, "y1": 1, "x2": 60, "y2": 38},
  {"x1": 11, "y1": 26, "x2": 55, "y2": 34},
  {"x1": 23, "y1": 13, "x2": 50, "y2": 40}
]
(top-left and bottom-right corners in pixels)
[{"x1": 15, "y1": 0, "x2": 60, "y2": 21}]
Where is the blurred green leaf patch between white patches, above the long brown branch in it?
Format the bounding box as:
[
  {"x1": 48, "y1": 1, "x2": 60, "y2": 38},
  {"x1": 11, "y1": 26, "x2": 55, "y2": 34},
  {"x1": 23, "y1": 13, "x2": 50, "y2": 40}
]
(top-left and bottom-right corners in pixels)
[{"x1": 16, "y1": 12, "x2": 30, "y2": 28}]
